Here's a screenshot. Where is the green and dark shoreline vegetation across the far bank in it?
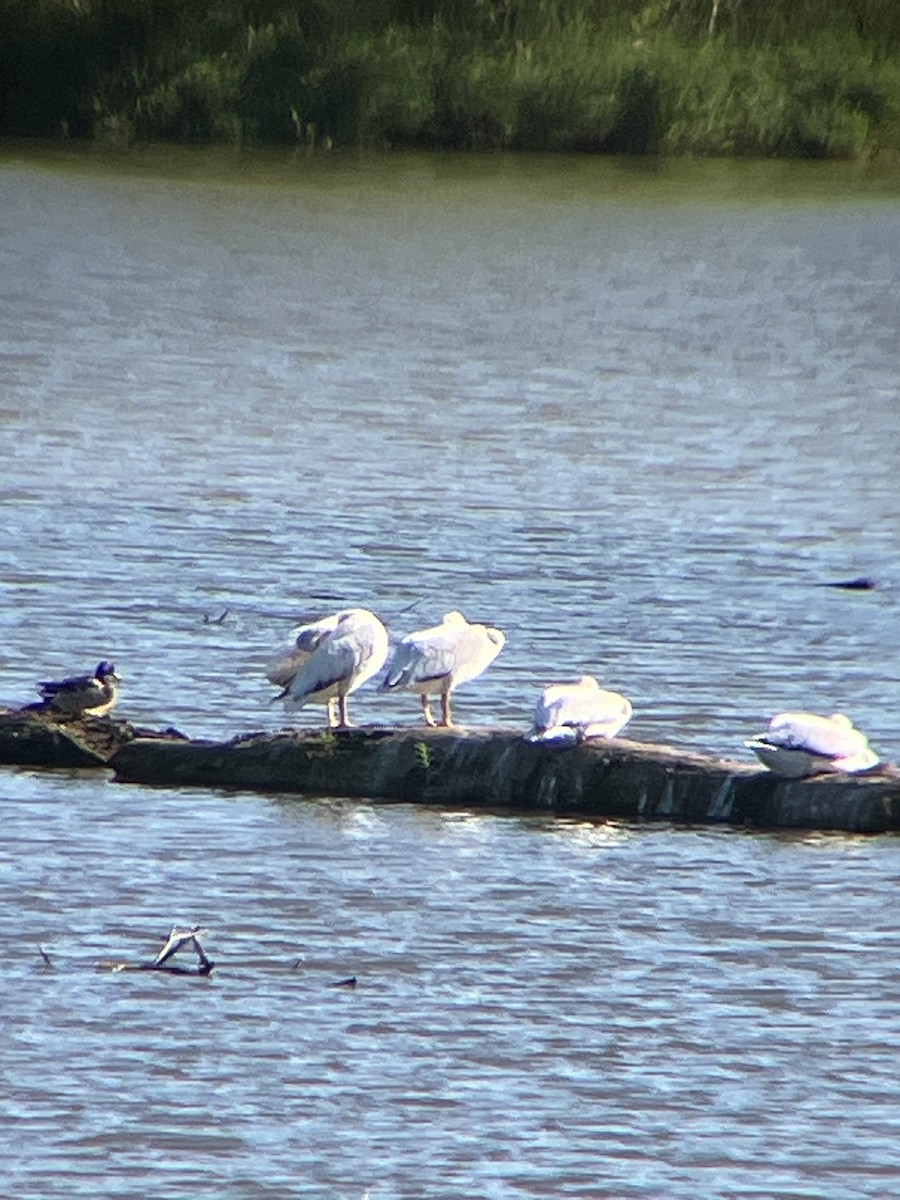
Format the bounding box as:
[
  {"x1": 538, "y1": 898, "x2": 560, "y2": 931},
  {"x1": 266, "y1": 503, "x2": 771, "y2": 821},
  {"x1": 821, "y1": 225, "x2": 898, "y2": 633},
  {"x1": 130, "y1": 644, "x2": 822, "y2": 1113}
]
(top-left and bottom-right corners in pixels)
[{"x1": 0, "y1": 0, "x2": 900, "y2": 158}]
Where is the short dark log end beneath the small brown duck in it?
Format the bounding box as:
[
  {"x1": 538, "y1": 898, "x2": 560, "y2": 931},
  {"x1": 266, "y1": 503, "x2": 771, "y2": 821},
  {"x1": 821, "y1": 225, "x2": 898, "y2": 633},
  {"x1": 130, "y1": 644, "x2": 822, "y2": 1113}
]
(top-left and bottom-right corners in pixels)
[{"x1": 0, "y1": 704, "x2": 186, "y2": 767}]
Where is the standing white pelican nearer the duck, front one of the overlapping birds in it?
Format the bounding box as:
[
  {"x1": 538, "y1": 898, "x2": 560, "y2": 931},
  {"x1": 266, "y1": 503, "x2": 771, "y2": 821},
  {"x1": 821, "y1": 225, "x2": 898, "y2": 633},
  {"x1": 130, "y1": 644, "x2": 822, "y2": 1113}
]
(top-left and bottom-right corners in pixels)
[{"x1": 278, "y1": 608, "x2": 388, "y2": 728}]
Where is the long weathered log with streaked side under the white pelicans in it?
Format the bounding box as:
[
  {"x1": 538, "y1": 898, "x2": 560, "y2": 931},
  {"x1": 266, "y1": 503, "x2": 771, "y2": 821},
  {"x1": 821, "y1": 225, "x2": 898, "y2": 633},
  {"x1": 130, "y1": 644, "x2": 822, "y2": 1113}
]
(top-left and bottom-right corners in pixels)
[{"x1": 109, "y1": 728, "x2": 900, "y2": 833}]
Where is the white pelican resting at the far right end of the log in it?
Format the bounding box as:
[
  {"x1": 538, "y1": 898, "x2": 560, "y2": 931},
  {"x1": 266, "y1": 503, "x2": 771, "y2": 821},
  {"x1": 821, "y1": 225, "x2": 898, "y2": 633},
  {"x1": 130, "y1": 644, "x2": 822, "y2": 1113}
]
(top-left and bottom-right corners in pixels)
[{"x1": 744, "y1": 713, "x2": 878, "y2": 779}]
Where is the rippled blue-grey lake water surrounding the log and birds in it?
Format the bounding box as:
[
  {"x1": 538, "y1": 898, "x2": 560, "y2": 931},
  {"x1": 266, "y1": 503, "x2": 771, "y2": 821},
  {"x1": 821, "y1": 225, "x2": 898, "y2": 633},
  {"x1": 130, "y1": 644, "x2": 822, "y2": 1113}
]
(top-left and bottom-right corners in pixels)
[{"x1": 0, "y1": 148, "x2": 900, "y2": 1200}]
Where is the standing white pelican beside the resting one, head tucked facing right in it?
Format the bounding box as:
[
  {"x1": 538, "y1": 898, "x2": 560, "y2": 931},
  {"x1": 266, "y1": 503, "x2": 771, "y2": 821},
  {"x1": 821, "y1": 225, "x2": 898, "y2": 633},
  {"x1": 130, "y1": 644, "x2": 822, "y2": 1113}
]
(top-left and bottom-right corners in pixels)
[{"x1": 382, "y1": 612, "x2": 506, "y2": 728}]
